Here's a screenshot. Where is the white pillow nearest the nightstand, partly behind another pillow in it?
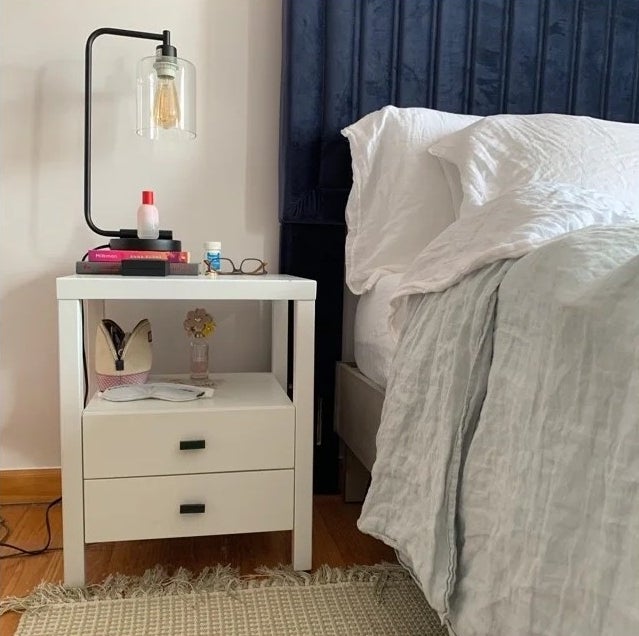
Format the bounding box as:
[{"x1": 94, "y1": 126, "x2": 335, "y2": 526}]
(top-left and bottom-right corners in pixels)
[{"x1": 342, "y1": 106, "x2": 479, "y2": 294}]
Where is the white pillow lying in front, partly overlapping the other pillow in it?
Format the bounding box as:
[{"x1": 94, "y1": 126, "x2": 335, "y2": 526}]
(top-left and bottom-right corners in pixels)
[{"x1": 430, "y1": 114, "x2": 639, "y2": 217}]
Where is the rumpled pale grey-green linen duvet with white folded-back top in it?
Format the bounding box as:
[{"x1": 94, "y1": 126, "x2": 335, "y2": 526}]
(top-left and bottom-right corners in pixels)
[{"x1": 358, "y1": 183, "x2": 639, "y2": 636}]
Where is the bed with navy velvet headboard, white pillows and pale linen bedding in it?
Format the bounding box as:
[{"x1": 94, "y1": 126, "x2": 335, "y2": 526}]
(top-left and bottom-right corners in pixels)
[{"x1": 281, "y1": 0, "x2": 639, "y2": 636}]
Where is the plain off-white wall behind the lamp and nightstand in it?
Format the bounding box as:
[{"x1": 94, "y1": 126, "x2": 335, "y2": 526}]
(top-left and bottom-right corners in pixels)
[{"x1": 0, "y1": 0, "x2": 281, "y2": 469}]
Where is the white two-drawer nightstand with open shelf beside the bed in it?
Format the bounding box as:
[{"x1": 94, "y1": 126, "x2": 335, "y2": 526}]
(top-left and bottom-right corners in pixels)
[{"x1": 57, "y1": 275, "x2": 316, "y2": 585}]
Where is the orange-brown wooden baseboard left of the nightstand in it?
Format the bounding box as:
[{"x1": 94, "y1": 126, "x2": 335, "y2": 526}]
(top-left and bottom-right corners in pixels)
[{"x1": 0, "y1": 468, "x2": 62, "y2": 504}]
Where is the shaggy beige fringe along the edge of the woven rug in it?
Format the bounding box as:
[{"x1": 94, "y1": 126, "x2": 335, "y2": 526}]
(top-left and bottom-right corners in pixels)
[{"x1": 0, "y1": 563, "x2": 410, "y2": 615}]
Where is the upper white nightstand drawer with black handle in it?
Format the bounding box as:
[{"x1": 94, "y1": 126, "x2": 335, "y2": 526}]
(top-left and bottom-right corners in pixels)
[{"x1": 83, "y1": 407, "x2": 295, "y2": 479}]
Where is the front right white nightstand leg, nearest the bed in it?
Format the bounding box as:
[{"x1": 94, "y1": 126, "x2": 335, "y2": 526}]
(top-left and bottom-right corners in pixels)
[{"x1": 293, "y1": 300, "x2": 315, "y2": 570}]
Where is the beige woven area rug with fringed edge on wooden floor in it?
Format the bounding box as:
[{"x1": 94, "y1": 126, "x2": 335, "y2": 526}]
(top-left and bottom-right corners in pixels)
[{"x1": 0, "y1": 564, "x2": 446, "y2": 636}]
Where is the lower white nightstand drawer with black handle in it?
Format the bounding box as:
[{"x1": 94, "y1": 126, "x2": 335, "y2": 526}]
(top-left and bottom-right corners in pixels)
[{"x1": 84, "y1": 470, "x2": 294, "y2": 543}]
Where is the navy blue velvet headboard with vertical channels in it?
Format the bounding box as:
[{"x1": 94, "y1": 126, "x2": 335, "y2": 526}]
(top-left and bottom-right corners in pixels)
[{"x1": 280, "y1": 0, "x2": 639, "y2": 491}]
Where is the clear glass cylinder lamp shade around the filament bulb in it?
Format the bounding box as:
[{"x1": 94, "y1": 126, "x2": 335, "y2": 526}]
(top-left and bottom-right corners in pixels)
[{"x1": 136, "y1": 55, "x2": 196, "y2": 139}]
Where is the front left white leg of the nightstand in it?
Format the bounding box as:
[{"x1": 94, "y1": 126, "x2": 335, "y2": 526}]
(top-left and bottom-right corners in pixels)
[{"x1": 58, "y1": 300, "x2": 84, "y2": 586}]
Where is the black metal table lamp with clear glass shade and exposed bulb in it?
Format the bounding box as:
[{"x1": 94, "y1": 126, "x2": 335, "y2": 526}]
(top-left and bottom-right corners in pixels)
[{"x1": 84, "y1": 28, "x2": 196, "y2": 251}]
